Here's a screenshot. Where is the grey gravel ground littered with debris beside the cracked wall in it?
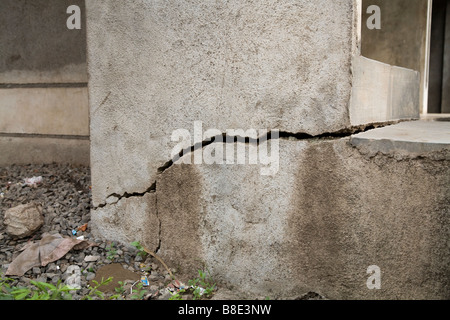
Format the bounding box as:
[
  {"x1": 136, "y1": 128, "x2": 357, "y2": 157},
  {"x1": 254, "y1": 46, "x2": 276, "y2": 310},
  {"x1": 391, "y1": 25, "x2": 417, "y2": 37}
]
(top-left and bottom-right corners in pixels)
[{"x1": 0, "y1": 164, "x2": 185, "y2": 300}]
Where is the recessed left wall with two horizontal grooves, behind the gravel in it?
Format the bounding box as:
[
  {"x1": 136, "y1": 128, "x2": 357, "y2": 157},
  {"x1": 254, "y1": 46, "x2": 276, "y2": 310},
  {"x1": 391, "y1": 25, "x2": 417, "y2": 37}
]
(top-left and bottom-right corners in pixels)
[{"x1": 0, "y1": 0, "x2": 89, "y2": 165}]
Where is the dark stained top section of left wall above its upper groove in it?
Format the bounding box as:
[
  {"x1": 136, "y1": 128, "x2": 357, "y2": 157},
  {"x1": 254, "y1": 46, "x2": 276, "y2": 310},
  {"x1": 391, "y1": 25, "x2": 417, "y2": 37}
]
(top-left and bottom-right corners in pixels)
[{"x1": 0, "y1": 0, "x2": 87, "y2": 83}]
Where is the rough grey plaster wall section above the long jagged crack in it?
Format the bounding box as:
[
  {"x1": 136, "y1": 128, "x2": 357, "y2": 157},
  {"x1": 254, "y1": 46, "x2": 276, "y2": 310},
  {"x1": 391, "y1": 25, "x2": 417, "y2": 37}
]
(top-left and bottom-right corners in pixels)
[{"x1": 86, "y1": 0, "x2": 354, "y2": 205}]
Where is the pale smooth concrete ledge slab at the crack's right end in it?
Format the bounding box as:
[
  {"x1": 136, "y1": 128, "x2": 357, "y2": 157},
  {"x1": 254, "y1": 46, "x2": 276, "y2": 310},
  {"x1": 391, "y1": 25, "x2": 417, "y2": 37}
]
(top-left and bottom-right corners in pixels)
[{"x1": 350, "y1": 121, "x2": 450, "y2": 155}]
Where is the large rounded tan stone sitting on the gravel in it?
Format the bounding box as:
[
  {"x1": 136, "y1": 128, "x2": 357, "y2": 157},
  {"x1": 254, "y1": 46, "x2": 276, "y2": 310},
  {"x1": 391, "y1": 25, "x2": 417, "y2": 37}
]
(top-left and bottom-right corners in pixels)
[{"x1": 4, "y1": 203, "x2": 44, "y2": 238}]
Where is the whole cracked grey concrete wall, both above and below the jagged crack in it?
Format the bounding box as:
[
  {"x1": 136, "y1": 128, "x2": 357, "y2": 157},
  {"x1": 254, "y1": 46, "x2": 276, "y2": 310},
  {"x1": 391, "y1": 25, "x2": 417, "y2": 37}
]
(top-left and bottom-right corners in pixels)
[{"x1": 86, "y1": 0, "x2": 449, "y2": 299}]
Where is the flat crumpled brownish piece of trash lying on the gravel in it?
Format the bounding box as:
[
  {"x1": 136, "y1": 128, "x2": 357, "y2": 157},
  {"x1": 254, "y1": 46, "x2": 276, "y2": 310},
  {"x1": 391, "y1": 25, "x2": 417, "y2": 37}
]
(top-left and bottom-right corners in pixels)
[{"x1": 5, "y1": 233, "x2": 97, "y2": 276}]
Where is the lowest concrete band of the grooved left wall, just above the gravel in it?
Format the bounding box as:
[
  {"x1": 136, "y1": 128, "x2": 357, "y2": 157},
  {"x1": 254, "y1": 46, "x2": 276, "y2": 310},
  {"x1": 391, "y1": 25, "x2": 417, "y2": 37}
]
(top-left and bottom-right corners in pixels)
[{"x1": 0, "y1": 136, "x2": 90, "y2": 166}]
